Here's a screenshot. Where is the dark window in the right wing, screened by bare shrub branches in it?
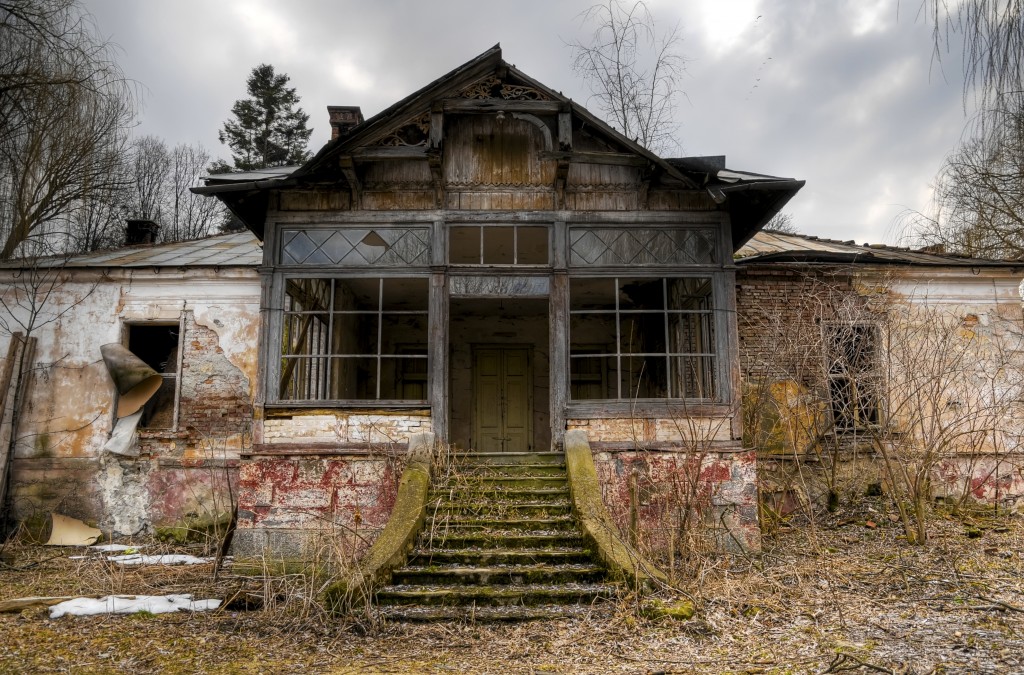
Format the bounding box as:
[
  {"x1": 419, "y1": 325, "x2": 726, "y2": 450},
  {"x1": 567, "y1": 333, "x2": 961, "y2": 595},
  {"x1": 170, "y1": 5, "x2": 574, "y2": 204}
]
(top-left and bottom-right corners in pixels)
[{"x1": 823, "y1": 324, "x2": 881, "y2": 431}]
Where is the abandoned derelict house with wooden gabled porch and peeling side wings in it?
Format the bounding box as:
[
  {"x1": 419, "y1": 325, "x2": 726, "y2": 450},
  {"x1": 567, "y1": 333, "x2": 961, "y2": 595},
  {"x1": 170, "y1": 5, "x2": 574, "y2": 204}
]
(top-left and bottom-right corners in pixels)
[{"x1": 0, "y1": 47, "x2": 1022, "y2": 581}]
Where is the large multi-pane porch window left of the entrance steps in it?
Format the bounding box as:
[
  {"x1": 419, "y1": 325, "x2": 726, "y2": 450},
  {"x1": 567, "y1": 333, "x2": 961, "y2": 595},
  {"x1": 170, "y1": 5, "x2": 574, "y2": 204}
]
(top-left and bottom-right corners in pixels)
[{"x1": 279, "y1": 278, "x2": 428, "y2": 402}]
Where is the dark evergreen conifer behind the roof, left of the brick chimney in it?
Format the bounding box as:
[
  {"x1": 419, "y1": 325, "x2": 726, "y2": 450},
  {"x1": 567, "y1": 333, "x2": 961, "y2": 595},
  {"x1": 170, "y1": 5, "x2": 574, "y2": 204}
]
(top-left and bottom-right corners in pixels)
[{"x1": 219, "y1": 64, "x2": 312, "y2": 171}]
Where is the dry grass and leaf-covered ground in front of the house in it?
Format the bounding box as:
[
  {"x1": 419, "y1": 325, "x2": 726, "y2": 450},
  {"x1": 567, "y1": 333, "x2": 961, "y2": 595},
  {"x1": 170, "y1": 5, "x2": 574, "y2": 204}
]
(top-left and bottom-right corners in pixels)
[{"x1": 0, "y1": 504, "x2": 1024, "y2": 675}]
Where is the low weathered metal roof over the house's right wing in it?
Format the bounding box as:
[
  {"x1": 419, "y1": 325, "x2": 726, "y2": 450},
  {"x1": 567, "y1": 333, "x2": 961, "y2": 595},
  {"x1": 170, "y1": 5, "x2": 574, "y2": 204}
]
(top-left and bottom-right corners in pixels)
[{"x1": 735, "y1": 230, "x2": 1024, "y2": 267}]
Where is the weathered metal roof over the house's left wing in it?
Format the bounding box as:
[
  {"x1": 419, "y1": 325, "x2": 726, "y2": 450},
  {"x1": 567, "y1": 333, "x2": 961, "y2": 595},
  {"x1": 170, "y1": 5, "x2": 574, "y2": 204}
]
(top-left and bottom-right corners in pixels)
[{"x1": 2, "y1": 230, "x2": 263, "y2": 267}]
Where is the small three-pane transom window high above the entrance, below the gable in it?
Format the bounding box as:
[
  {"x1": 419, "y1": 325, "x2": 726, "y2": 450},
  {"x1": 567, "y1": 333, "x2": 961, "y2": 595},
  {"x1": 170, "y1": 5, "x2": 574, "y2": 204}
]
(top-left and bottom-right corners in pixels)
[{"x1": 449, "y1": 225, "x2": 549, "y2": 265}]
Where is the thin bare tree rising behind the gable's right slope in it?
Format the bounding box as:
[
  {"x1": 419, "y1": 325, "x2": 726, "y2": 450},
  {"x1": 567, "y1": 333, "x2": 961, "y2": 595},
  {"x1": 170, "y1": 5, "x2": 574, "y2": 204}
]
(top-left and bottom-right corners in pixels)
[{"x1": 569, "y1": 0, "x2": 685, "y2": 152}]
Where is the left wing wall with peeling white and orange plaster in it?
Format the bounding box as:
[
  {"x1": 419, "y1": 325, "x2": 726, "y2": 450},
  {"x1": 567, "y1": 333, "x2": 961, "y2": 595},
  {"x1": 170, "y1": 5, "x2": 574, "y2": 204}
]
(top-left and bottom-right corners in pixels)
[{"x1": 0, "y1": 268, "x2": 260, "y2": 535}]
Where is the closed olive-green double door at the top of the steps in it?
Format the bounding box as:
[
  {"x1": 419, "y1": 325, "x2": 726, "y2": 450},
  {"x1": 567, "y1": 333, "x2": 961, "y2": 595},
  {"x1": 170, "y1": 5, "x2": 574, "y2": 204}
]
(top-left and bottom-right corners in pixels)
[{"x1": 473, "y1": 347, "x2": 534, "y2": 453}]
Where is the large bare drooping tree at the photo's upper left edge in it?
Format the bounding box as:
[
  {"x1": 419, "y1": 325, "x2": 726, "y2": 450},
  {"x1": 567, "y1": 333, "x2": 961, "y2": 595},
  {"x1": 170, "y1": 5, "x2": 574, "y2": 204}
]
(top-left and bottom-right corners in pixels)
[{"x1": 0, "y1": 0, "x2": 135, "y2": 259}]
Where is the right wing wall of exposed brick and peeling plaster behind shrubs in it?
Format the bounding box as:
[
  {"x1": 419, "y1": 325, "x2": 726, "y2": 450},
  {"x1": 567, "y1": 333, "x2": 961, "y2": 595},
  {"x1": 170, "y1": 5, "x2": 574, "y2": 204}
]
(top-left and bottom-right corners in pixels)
[{"x1": 737, "y1": 265, "x2": 1024, "y2": 508}]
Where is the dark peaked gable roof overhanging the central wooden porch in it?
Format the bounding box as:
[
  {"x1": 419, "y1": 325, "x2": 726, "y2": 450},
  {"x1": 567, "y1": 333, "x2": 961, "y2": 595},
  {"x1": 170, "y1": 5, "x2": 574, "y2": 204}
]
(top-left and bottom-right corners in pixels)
[{"x1": 193, "y1": 45, "x2": 804, "y2": 248}]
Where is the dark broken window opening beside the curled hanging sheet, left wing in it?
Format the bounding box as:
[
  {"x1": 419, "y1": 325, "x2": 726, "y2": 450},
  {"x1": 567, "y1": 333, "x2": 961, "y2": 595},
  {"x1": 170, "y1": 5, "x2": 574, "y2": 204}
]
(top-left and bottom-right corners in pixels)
[{"x1": 128, "y1": 324, "x2": 180, "y2": 429}]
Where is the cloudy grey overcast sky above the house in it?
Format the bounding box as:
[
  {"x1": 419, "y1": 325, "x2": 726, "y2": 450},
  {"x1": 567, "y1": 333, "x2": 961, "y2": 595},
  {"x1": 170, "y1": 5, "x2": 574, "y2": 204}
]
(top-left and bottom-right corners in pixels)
[{"x1": 84, "y1": 0, "x2": 966, "y2": 243}]
